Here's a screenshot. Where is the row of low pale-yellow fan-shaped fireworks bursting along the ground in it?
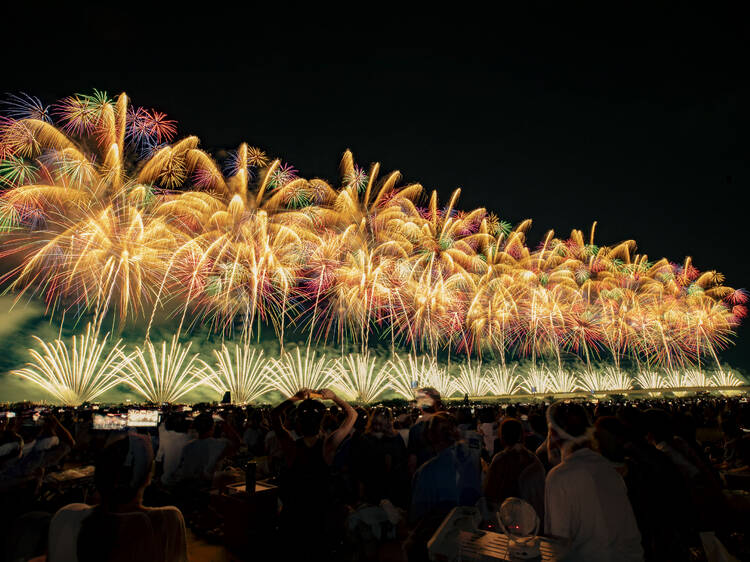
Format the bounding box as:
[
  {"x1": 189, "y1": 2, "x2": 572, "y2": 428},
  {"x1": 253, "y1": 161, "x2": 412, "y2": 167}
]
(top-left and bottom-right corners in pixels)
[{"x1": 7, "y1": 325, "x2": 744, "y2": 405}]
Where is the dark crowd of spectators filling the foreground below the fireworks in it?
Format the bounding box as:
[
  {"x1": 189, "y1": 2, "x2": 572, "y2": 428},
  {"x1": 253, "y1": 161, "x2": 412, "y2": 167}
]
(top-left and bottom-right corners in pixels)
[{"x1": 0, "y1": 388, "x2": 750, "y2": 562}]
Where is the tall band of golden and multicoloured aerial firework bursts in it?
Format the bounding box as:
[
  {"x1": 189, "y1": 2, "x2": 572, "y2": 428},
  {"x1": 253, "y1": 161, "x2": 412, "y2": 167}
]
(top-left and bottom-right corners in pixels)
[{"x1": 0, "y1": 92, "x2": 746, "y2": 372}]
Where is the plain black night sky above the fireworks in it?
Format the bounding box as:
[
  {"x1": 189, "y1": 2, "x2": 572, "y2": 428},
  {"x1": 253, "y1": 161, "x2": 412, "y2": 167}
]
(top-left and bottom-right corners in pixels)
[{"x1": 5, "y1": 8, "x2": 750, "y2": 369}]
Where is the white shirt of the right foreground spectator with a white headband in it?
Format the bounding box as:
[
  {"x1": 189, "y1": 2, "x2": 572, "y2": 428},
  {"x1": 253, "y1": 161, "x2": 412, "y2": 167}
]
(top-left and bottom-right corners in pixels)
[{"x1": 544, "y1": 448, "x2": 643, "y2": 562}]
